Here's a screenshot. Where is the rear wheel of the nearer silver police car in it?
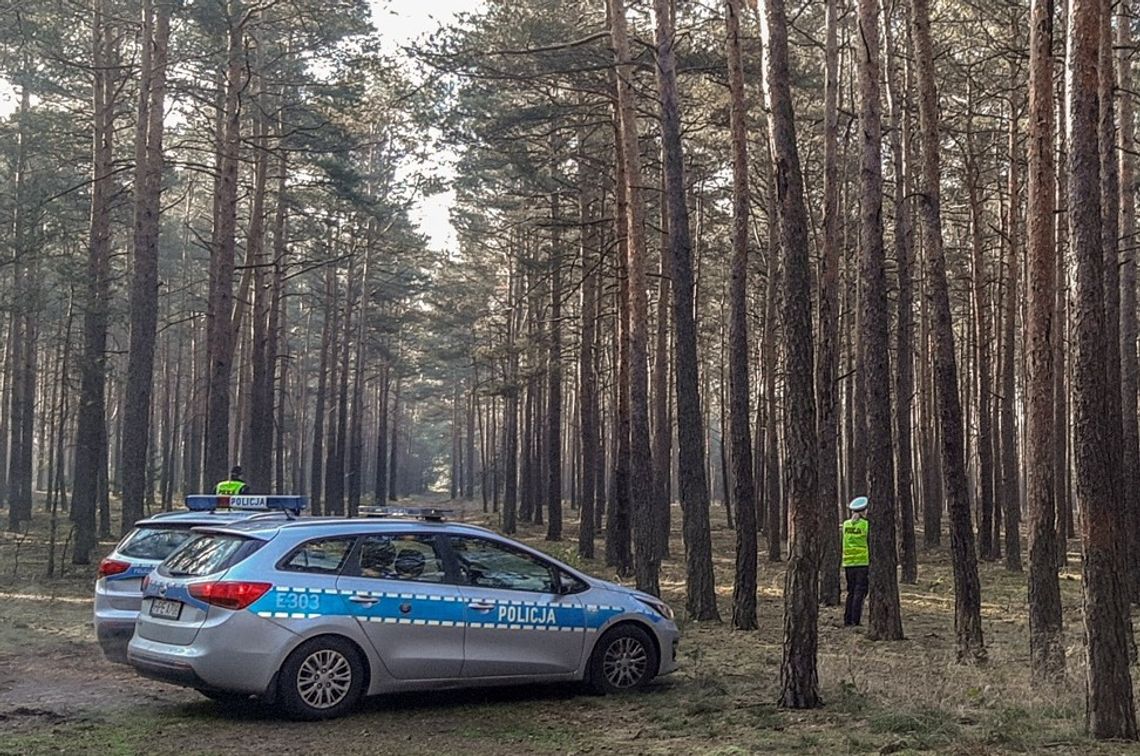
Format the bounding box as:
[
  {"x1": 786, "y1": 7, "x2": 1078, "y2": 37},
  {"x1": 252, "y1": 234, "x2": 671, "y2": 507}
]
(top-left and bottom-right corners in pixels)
[{"x1": 277, "y1": 635, "x2": 365, "y2": 721}]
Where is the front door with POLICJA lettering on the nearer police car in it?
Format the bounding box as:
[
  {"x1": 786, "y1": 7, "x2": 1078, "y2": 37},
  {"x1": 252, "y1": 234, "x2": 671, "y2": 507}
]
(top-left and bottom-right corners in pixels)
[{"x1": 448, "y1": 535, "x2": 586, "y2": 677}]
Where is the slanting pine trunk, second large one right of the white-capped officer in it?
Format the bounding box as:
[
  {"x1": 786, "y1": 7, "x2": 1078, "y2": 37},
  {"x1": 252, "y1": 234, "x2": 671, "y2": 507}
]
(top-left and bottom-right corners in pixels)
[{"x1": 911, "y1": 0, "x2": 985, "y2": 661}]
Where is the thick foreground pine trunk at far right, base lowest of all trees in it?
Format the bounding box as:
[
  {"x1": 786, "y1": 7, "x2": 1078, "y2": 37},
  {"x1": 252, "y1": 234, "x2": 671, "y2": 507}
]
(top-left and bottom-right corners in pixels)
[{"x1": 1068, "y1": 0, "x2": 1137, "y2": 740}]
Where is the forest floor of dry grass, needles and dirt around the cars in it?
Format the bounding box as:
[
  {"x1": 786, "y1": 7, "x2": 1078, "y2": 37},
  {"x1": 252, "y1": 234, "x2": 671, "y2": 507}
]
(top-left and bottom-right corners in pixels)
[{"x1": 0, "y1": 504, "x2": 1140, "y2": 755}]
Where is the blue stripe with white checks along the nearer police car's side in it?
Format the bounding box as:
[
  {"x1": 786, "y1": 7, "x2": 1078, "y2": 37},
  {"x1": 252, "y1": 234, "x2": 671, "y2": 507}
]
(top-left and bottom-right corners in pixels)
[{"x1": 250, "y1": 586, "x2": 628, "y2": 633}]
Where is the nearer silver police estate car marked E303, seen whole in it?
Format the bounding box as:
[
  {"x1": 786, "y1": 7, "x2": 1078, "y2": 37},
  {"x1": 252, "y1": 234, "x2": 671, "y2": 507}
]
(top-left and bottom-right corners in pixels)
[{"x1": 128, "y1": 511, "x2": 679, "y2": 720}]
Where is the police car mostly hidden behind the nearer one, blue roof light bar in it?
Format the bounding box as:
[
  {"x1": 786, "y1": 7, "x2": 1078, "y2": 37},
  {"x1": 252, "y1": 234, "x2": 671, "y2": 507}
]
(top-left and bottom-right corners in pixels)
[{"x1": 95, "y1": 496, "x2": 304, "y2": 664}]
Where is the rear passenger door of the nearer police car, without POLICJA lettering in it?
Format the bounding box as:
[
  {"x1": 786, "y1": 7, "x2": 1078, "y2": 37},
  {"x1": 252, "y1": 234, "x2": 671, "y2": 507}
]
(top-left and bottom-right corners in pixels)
[{"x1": 336, "y1": 533, "x2": 464, "y2": 680}]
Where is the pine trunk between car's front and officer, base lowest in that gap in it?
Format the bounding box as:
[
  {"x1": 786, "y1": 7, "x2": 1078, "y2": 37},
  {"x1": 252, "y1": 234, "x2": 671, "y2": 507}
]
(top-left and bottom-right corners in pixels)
[{"x1": 764, "y1": 0, "x2": 822, "y2": 708}]
